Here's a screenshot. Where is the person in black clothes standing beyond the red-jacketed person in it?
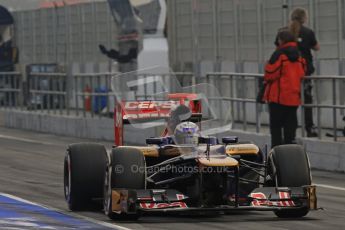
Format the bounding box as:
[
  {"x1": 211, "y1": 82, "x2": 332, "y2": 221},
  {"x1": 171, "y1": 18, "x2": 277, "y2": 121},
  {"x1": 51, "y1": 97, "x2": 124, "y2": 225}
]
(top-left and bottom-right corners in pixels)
[{"x1": 276, "y1": 8, "x2": 320, "y2": 137}]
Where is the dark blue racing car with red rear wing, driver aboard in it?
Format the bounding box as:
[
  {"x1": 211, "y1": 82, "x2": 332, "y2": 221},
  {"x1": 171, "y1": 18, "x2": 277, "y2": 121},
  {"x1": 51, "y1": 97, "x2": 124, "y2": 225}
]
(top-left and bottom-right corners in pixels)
[{"x1": 64, "y1": 93, "x2": 317, "y2": 219}]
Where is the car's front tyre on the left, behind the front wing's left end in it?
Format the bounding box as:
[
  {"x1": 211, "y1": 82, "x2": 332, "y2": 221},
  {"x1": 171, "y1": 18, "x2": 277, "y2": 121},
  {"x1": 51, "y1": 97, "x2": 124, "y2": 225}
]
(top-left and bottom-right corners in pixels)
[{"x1": 103, "y1": 147, "x2": 146, "y2": 220}]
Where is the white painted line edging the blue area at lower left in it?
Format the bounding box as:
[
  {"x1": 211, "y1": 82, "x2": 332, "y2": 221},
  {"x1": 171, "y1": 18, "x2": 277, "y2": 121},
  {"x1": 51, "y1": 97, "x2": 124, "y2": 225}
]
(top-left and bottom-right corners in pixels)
[{"x1": 0, "y1": 193, "x2": 130, "y2": 230}]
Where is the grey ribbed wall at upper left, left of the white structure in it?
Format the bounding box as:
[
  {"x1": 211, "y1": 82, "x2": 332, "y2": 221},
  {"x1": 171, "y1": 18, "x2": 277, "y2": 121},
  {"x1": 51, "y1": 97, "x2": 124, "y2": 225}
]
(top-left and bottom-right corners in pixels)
[{"x1": 13, "y1": 1, "x2": 119, "y2": 68}]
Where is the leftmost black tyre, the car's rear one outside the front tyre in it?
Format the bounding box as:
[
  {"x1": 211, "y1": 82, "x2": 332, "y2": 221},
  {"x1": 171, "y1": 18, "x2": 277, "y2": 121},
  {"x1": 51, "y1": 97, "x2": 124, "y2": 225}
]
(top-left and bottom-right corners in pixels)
[{"x1": 64, "y1": 143, "x2": 107, "y2": 211}]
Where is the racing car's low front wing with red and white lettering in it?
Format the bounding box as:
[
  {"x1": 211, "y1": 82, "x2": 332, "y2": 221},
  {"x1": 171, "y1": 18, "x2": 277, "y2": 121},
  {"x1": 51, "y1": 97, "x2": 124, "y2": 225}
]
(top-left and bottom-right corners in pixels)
[{"x1": 112, "y1": 185, "x2": 317, "y2": 213}]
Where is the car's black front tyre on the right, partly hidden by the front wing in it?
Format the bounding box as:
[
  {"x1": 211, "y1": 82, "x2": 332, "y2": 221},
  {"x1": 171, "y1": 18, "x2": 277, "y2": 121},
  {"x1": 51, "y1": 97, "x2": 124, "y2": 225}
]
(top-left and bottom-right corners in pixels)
[{"x1": 268, "y1": 145, "x2": 311, "y2": 218}]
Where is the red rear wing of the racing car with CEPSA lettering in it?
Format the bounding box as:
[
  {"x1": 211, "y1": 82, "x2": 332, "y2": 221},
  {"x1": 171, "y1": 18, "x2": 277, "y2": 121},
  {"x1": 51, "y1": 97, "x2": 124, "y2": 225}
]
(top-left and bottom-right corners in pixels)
[{"x1": 114, "y1": 93, "x2": 202, "y2": 146}]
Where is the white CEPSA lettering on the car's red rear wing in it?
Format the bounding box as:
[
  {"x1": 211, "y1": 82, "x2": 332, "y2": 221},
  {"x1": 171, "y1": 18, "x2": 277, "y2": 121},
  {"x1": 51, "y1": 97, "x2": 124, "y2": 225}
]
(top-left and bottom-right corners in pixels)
[{"x1": 124, "y1": 101, "x2": 180, "y2": 119}]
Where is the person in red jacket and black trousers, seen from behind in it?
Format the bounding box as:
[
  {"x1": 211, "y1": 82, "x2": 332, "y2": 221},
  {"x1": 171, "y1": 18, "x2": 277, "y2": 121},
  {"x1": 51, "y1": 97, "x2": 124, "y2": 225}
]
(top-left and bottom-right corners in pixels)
[{"x1": 264, "y1": 30, "x2": 306, "y2": 148}]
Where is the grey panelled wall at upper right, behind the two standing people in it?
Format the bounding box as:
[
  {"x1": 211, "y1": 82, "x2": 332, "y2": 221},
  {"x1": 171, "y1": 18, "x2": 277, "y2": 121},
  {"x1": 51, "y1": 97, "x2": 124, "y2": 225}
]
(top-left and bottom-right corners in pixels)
[{"x1": 168, "y1": 0, "x2": 345, "y2": 76}]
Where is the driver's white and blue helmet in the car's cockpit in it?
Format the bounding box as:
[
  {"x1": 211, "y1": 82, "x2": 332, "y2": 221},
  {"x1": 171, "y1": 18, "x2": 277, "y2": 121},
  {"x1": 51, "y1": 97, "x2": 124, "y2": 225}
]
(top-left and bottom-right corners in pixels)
[{"x1": 174, "y1": 121, "x2": 200, "y2": 145}]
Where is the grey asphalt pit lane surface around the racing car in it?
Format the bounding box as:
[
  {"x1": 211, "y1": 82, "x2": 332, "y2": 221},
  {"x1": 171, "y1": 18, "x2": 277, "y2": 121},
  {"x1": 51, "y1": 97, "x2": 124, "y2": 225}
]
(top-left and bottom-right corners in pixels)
[{"x1": 0, "y1": 127, "x2": 345, "y2": 230}]
